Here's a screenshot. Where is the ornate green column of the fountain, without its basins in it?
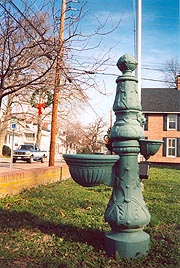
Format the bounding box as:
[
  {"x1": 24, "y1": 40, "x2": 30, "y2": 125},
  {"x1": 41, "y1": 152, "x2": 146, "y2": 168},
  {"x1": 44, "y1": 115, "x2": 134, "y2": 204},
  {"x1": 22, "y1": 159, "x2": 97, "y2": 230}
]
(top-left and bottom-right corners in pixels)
[{"x1": 105, "y1": 54, "x2": 150, "y2": 258}]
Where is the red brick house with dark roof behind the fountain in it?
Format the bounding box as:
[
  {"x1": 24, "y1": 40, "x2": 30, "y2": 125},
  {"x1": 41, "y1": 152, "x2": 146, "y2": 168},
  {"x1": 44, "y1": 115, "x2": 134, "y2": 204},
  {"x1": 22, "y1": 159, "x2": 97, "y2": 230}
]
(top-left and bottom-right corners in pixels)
[{"x1": 141, "y1": 77, "x2": 180, "y2": 164}]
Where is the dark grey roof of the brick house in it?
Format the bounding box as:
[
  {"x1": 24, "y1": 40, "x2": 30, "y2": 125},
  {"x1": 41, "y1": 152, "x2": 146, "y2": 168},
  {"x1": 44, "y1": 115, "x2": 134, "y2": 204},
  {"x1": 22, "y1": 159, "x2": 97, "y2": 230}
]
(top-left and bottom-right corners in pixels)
[{"x1": 141, "y1": 88, "x2": 180, "y2": 113}]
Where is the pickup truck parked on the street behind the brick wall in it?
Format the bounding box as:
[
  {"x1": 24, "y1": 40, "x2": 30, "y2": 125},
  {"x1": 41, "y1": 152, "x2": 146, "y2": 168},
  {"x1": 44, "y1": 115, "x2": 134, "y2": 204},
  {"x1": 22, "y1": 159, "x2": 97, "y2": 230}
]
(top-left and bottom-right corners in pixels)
[{"x1": 13, "y1": 144, "x2": 47, "y2": 164}]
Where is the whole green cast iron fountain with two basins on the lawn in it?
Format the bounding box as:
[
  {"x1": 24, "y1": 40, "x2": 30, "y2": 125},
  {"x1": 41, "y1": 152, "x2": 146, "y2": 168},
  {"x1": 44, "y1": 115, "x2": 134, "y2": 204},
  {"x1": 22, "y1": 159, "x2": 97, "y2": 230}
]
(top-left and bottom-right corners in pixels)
[{"x1": 64, "y1": 54, "x2": 162, "y2": 258}]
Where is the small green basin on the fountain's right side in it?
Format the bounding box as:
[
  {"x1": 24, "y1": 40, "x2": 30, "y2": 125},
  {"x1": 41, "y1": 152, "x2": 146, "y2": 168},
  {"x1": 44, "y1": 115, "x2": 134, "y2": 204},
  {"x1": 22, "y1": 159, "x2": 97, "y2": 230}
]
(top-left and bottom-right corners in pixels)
[{"x1": 139, "y1": 139, "x2": 163, "y2": 159}]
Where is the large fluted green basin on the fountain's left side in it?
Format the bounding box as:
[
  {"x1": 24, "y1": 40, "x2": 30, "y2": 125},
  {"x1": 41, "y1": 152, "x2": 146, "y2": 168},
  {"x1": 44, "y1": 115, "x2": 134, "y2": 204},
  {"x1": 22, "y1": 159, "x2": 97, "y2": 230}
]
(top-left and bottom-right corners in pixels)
[{"x1": 63, "y1": 154, "x2": 119, "y2": 187}]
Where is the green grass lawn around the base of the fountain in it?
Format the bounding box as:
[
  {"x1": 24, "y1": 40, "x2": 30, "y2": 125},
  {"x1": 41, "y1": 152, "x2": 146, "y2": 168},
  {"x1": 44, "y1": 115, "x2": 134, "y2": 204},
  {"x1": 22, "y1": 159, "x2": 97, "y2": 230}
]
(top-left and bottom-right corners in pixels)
[{"x1": 0, "y1": 168, "x2": 180, "y2": 268}]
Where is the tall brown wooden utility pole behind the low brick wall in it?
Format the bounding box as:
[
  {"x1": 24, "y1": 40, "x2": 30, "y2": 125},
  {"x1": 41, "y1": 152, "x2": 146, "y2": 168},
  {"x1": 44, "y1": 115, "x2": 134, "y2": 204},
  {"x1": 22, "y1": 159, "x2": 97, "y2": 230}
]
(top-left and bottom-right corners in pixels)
[{"x1": 49, "y1": 0, "x2": 66, "y2": 166}]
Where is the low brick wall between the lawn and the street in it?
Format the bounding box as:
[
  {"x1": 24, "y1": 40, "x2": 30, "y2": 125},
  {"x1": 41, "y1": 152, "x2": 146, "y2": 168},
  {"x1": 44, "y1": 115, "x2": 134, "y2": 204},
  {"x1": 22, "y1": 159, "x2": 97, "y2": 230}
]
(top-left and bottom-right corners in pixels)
[{"x1": 0, "y1": 165, "x2": 71, "y2": 198}]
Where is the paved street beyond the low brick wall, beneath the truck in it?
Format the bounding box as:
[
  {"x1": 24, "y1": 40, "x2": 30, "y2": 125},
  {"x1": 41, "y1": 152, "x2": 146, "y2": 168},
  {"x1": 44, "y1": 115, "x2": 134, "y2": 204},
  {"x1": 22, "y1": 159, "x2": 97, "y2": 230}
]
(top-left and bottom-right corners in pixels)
[{"x1": 0, "y1": 158, "x2": 65, "y2": 173}]
